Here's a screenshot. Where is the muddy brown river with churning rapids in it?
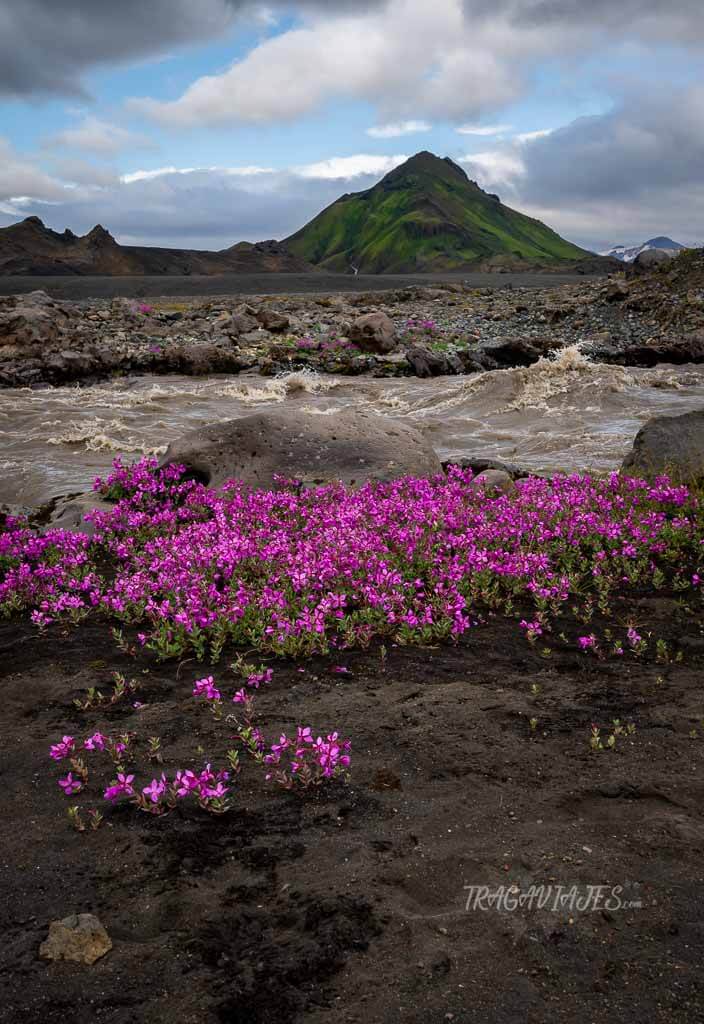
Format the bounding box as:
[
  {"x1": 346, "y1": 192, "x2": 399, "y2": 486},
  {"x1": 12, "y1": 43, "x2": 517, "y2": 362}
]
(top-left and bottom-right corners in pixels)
[{"x1": 0, "y1": 346, "x2": 704, "y2": 508}]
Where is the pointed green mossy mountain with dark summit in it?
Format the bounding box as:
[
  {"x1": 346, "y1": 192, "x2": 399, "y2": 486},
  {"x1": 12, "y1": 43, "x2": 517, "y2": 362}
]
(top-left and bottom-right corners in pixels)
[{"x1": 285, "y1": 153, "x2": 593, "y2": 273}]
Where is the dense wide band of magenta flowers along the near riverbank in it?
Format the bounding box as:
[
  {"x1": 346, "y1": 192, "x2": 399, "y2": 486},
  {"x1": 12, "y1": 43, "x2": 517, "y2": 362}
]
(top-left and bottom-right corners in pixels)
[{"x1": 0, "y1": 460, "x2": 704, "y2": 659}]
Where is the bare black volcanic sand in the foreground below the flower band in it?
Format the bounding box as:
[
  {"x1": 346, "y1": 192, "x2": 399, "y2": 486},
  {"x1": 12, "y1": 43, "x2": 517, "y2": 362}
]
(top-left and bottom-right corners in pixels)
[{"x1": 0, "y1": 599, "x2": 704, "y2": 1024}]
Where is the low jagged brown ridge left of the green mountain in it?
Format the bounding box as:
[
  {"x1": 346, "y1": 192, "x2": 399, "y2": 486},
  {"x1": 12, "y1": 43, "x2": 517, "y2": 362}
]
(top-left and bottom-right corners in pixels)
[{"x1": 0, "y1": 217, "x2": 314, "y2": 276}]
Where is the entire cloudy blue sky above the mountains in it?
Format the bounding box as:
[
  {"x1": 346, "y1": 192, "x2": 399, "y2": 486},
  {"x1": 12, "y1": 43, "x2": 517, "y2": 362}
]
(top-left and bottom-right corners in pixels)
[{"x1": 0, "y1": 0, "x2": 704, "y2": 251}]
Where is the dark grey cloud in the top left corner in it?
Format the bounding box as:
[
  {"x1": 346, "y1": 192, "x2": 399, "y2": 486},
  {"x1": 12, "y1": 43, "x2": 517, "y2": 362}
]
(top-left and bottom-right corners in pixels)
[{"x1": 0, "y1": 0, "x2": 390, "y2": 96}]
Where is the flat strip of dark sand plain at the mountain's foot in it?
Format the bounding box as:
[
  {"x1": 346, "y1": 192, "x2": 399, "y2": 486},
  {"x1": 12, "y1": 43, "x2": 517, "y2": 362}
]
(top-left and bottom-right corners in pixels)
[{"x1": 0, "y1": 268, "x2": 611, "y2": 302}]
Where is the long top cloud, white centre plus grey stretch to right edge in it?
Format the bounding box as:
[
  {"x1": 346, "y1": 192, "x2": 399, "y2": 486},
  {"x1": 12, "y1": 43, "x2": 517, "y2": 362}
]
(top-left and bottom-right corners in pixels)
[{"x1": 133, "y1": 0, "x2": 704, "y2": 126}]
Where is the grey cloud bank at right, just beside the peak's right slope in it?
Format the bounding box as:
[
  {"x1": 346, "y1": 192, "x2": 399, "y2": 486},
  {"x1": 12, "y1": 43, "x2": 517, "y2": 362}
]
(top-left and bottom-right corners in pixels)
[{"x1": 463, "y1": 85, "x2": 704, "y2": 249}]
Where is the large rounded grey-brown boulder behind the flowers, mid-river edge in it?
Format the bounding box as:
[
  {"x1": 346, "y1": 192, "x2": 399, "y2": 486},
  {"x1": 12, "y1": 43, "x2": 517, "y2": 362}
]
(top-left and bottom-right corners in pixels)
[{"x1": 162, "y1": 410, "x2": 442, "y2": 489}]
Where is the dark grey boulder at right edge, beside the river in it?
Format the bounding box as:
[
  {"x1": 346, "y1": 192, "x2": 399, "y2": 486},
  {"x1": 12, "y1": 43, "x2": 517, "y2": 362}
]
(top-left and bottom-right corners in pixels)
[{"x1": 621, "y1": 410, "x2": 704, "y2": 483}]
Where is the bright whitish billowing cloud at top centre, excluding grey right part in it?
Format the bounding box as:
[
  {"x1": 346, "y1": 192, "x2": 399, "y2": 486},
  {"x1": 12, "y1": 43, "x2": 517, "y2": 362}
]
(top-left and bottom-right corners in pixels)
[{"x1": 133, "y1": 0, "x2": 528, "y2": 126}]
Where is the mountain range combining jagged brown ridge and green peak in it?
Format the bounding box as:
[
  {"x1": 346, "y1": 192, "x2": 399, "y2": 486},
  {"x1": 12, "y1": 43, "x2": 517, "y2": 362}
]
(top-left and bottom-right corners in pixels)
[{"x1": 0, "y1": 152, "x2": 605, "y2": 276}]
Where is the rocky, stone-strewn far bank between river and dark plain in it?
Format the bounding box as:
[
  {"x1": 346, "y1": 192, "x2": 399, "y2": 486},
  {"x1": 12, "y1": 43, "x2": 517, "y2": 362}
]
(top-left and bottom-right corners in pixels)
[{"x1": 0, "y1": 266, "x2": 704, "y2": 387}]
